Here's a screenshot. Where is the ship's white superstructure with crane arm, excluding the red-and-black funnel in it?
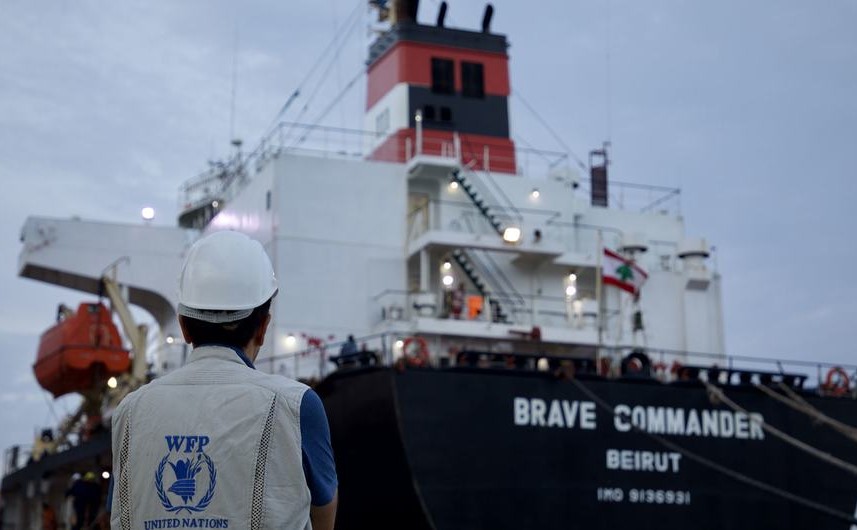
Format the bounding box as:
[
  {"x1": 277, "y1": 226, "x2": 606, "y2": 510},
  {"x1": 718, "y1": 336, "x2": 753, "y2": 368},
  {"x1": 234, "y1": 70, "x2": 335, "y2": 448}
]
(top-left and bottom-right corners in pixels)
[{"x1": 20, "y1": 133, "x2": 724, "y2": 377}]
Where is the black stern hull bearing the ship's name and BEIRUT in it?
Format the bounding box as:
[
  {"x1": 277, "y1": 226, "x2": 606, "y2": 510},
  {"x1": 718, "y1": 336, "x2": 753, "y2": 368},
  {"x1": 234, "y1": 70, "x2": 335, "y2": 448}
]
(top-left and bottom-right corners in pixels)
[{"x1": 318, "y1": 369, "x2": 857, "y2": 530}]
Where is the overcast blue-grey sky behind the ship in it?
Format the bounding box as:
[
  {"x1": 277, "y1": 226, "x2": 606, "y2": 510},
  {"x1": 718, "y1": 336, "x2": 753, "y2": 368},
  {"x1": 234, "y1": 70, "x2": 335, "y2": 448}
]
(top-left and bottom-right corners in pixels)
[{"x1": 0, "y1": 0, "x2": 857, "y2": 454}]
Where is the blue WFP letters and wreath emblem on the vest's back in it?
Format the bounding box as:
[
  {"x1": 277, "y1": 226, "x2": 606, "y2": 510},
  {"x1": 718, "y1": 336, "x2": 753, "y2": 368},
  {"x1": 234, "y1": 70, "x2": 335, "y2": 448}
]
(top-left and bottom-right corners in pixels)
[{"x1": 155, "y1": 435, "x2": 217, "y2": 514}]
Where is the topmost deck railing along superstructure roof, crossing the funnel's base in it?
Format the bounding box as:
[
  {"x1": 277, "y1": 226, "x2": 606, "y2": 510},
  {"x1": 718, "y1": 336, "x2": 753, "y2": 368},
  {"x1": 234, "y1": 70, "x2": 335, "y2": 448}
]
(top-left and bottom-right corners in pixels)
[{"x1": 178, "y1": 121, "x2": 681, "y2": 220}]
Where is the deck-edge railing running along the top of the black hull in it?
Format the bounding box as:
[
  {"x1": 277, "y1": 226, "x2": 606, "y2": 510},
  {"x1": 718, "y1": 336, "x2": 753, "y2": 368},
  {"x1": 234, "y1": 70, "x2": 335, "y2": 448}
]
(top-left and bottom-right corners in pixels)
[{"x1": 260, "y1": 330, "x2": 857, "y2": 396}]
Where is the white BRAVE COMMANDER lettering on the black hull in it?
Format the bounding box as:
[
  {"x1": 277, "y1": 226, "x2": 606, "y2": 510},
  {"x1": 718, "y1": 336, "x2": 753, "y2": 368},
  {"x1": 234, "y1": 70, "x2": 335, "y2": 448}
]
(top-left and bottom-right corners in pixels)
[{"x1": 512, "y1": 397, "x2": 765, "y2": 440}]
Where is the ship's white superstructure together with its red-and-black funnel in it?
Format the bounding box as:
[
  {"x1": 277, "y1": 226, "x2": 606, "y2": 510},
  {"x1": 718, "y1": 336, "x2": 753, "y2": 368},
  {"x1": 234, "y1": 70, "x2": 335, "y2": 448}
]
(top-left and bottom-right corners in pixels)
[{"x1": 19, "y1": 6, "x2": 724, "y2": 378}]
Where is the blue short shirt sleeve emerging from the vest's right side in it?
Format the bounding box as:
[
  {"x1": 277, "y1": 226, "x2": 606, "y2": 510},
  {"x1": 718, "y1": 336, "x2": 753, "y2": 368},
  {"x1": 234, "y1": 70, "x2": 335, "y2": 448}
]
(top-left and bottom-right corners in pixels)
[{"x1": 301, "y1": 389, "x2": 337, "y2": 506}]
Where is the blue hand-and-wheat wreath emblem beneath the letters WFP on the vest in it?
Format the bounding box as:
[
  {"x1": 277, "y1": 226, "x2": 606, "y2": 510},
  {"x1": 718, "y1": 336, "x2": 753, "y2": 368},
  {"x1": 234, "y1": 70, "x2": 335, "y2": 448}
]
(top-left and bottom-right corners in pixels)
[{"x1": 155, "y1": 452, "x2": 217, "y2": 513}]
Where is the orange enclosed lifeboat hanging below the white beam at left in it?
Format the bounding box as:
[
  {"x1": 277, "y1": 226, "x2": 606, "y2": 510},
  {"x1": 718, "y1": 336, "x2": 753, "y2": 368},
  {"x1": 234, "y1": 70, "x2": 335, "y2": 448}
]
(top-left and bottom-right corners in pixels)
[{"x1": 33, "y1": 303, "x2": 131, "y2": 397}]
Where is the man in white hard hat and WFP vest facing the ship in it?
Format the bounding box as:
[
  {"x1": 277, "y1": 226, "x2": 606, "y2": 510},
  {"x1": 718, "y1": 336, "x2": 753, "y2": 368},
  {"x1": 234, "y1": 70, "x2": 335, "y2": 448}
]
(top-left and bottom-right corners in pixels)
[{"x1": 111, "y1": 232, "x2": 337, "y2": 530}]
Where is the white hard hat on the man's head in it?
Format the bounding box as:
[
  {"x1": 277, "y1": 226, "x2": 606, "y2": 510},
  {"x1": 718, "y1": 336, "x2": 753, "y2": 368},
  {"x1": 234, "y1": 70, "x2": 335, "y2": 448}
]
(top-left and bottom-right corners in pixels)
[{"x1": 178, "y1": 231, "x2": 277, "y2": 323}]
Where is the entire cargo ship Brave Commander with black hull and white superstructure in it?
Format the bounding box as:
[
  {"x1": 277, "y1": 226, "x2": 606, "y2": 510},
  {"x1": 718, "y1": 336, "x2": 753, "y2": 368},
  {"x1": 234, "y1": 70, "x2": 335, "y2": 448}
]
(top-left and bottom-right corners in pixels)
[{"x1": 2, "y1": 0, "x2": 857, "y2": 530}]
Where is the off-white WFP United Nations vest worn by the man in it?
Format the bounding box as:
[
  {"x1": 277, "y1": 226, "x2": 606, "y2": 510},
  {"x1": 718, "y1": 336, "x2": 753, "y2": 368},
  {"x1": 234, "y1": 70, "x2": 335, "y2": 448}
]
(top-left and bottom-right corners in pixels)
[{"x1": 110, "y1": 346, "x2": 310, "y2": 530}]
